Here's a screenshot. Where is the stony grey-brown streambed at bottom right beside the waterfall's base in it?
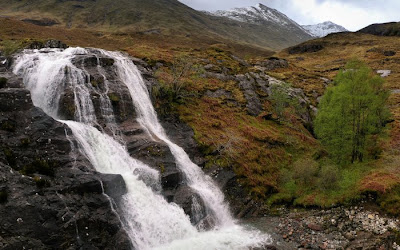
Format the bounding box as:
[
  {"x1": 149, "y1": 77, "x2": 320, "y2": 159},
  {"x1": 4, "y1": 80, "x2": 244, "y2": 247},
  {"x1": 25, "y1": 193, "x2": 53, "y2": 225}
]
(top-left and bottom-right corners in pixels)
[{"x1": 245, "y1": 202, "x2": 400, "y2": 250}]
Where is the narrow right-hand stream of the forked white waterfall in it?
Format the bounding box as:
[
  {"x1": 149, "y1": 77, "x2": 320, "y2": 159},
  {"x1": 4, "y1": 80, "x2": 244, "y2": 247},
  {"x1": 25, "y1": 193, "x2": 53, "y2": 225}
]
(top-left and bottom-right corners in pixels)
[{"x1": 102, "y1": 51, "x2": 233, "y2": 227}]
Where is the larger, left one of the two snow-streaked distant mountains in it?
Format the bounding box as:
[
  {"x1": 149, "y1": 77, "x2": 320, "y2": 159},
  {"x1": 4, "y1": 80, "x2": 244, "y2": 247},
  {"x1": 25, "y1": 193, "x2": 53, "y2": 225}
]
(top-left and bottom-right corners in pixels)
[{"x1": 208, "y1": 4, "x2": 311, "y2": 40}]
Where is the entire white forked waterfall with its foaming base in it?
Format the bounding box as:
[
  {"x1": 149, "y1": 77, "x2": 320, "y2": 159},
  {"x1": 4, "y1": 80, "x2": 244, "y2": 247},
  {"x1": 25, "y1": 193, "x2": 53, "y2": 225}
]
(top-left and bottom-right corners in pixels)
[{"x1": 14, "y1": 48, "x2": 269, "y2": 249}]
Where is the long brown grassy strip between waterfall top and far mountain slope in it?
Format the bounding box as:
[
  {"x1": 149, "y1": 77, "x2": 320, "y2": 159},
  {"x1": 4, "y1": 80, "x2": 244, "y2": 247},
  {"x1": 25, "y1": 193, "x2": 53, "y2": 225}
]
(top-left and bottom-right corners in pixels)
[{"x1": 0, "y1": 17, "x2": 273, "y2": 60}]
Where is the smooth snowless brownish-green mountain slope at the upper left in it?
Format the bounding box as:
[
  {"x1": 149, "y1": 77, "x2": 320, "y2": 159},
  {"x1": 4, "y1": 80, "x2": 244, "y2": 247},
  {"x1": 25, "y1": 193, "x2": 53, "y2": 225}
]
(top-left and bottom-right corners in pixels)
[{"x1": 0, "y1": 0, "x2": 311, "y2": 50}]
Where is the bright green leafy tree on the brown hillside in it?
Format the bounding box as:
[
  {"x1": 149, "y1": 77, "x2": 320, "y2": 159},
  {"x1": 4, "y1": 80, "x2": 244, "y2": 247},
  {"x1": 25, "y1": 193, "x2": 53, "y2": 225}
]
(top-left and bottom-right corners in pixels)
[{"x1": 315, "y1": 60, "x2": 390, "y2": 164}]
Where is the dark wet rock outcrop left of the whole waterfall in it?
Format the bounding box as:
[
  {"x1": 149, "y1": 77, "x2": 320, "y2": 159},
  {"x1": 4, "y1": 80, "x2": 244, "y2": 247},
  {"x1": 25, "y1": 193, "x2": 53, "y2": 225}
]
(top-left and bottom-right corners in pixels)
[{"x1": 0, "y1": 68, "x2": 131, "y2": 249}]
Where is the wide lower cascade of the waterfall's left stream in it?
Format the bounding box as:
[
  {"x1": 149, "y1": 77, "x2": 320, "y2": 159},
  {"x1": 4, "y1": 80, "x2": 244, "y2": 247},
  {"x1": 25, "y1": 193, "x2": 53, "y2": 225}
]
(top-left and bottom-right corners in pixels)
[{"x1": 64, "y1": 121, "x2": 196, "y2": 249}]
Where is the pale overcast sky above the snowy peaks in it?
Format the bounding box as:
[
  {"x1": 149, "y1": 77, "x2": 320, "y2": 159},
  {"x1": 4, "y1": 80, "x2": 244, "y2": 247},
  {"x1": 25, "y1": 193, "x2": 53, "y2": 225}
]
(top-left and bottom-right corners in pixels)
[{"x1": 180, "y1": 0, "x2": 400, "y2": 31}]
